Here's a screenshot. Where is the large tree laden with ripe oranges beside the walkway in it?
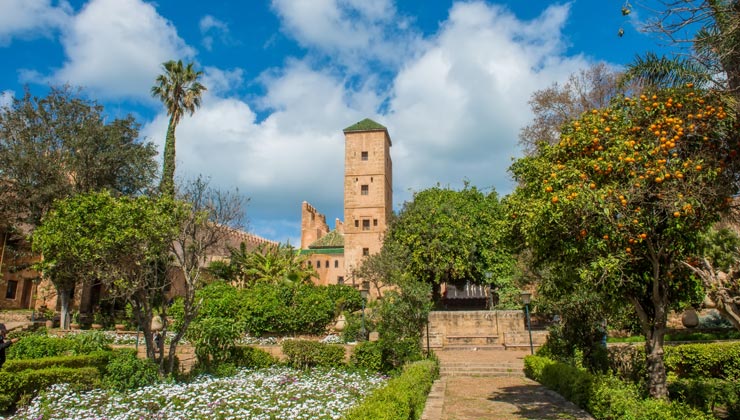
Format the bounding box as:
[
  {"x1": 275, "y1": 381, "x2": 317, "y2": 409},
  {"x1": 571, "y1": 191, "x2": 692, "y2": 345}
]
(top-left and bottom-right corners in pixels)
[{"x1": 508, "y1": 84, "x2": 738, "y2": 398}]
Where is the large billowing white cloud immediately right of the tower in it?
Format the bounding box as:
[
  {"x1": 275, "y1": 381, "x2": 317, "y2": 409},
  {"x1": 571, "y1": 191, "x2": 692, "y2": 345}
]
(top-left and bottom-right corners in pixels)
[{"x1": 387, "y1": 2, "x2": 588, "y2": 195}]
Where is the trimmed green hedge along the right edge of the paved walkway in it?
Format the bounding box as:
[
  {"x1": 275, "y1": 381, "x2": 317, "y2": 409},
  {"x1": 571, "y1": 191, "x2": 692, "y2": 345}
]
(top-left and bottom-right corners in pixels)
[{"x1": 524, "y1": 356, "x2": 713, "y2": 420}]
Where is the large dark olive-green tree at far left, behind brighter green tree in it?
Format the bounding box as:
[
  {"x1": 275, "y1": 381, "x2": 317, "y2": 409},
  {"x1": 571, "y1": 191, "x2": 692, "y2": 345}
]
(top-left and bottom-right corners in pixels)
[{"x1": 0, "y1": 86, "x2": 157, "y2": 230}]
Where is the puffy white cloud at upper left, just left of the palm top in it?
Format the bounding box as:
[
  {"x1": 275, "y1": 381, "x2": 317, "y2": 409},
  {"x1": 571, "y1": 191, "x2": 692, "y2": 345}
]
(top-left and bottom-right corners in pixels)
[{"x1": 43, "y1": 0, "x2": 194, "y2": 98}]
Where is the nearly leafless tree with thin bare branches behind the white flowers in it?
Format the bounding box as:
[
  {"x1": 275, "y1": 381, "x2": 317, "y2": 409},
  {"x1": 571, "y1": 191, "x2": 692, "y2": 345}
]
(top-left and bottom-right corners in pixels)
[{"x1": 164, "y1": 178, "x2": 244, "y2": 371}]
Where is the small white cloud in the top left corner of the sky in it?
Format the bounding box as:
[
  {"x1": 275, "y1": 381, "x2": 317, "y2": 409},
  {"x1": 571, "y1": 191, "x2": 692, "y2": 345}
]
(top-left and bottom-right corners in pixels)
[{"x1": 0, "y1": 0, "x2": 72, "y2": 47}]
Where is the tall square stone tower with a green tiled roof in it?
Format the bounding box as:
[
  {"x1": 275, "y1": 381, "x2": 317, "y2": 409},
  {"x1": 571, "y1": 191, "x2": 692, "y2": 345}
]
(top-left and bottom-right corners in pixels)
[{"x1": 344, "y1": 119, "x2": 393, "y2": 282}]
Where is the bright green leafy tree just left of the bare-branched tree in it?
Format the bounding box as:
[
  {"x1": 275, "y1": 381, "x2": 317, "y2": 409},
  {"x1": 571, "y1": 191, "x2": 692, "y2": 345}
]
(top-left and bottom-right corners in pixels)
[{"x1": 32, "y1": 191, "x2": 183, "y2": 334}]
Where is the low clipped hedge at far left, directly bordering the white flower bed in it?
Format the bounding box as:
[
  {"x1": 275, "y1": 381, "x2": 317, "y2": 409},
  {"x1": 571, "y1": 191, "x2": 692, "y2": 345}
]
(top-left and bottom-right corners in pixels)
[{"x1": 0, "y1": 367, "x2": 100, "y2": 411}]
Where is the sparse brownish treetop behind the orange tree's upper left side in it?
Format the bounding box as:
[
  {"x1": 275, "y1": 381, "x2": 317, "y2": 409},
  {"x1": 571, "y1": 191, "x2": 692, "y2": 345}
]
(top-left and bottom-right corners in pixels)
[{"x1": 519, "y1": 63, "x2": 621, "y2": 157}]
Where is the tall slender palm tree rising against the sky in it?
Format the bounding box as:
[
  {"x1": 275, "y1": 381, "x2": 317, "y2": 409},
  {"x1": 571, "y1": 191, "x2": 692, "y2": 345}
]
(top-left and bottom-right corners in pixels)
[{"x1": 151, "y1": 60, "x2": 207, "y2": 197}]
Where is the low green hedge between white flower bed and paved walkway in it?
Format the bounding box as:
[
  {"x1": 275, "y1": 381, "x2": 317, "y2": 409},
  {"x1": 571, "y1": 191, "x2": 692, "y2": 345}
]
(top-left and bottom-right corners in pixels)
[{"x1": 344, "y1": 360, "x2": 439, "y2": 420}]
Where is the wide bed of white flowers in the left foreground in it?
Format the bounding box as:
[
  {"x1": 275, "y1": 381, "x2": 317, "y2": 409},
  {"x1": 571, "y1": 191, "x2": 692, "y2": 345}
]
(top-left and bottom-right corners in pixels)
[{"x1": 11, "y1": 367, "x2": 386, "y2": 420}]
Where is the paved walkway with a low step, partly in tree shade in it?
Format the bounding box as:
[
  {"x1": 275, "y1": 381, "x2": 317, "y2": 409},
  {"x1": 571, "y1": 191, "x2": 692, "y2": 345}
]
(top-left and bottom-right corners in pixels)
[{"x1": 422, "y1": 350, "x2": 593, "y2": 420}]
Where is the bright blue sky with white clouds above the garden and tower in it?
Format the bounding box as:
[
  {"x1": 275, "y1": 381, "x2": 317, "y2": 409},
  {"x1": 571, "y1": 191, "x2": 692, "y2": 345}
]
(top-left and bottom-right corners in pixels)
[{"x1": 0, "y1": 0, "x2": 672, "y2": 244}]
